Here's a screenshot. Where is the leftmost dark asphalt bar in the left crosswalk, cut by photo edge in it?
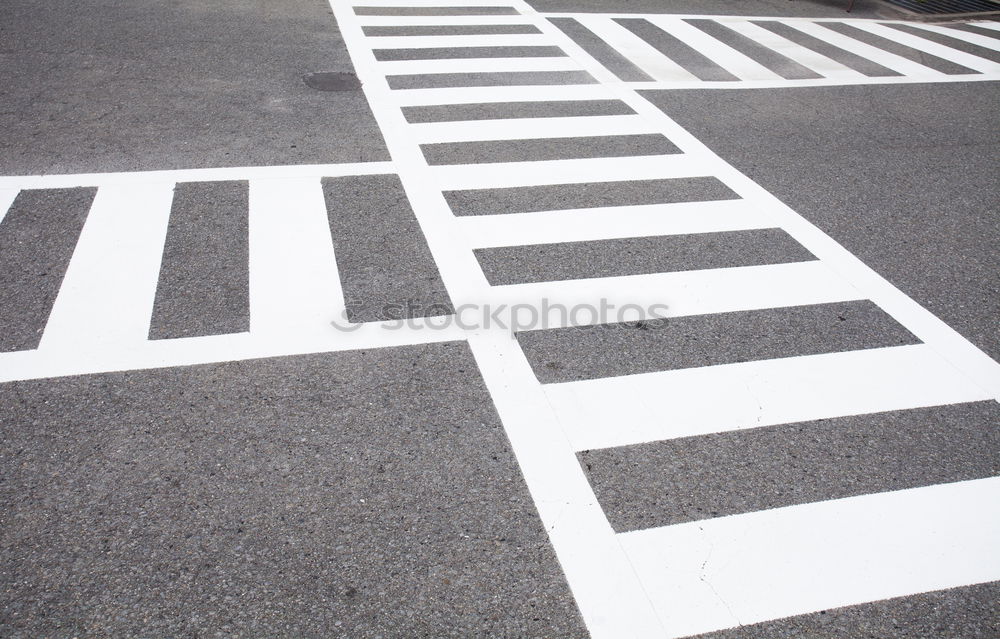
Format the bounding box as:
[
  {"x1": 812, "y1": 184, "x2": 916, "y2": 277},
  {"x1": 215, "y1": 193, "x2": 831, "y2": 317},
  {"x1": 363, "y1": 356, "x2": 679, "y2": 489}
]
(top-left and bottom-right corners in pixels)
[{"x1": 0, "y1": 189, "x2": 97, "y2": 352}]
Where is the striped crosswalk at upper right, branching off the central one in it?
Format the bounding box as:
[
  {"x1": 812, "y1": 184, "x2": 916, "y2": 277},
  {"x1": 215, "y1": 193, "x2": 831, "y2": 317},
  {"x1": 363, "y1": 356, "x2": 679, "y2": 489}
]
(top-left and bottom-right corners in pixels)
[{"x1": 547, "y1": 14, "x2": 1000, "y2": 88}]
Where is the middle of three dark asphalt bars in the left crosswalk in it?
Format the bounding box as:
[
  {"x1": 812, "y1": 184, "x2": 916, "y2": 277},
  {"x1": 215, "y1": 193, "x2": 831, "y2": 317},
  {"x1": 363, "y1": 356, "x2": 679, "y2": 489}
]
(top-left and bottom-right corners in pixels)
[{"x1": 149, "y1": 181, "x2": 250, "y2": 339}]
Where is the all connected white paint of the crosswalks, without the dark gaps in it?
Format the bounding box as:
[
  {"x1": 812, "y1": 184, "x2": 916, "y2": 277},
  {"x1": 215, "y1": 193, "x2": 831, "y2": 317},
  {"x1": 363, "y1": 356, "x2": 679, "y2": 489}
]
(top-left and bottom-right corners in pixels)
[{"x1": 0, "y1": 0, "x2": 1000, "y2": 639}]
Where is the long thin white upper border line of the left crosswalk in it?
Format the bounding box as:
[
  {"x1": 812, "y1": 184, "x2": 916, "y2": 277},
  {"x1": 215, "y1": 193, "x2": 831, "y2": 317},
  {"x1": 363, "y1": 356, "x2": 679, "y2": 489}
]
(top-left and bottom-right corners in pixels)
[{"x1": 0, "y1": 162, "x2": 396, "y2": 189}]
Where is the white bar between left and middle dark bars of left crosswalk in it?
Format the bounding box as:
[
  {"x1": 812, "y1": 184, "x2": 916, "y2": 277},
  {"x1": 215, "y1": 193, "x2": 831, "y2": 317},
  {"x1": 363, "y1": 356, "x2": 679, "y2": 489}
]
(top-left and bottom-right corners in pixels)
[{"x1": 39, "y1": 182, "x2": 174, "y2": 361}]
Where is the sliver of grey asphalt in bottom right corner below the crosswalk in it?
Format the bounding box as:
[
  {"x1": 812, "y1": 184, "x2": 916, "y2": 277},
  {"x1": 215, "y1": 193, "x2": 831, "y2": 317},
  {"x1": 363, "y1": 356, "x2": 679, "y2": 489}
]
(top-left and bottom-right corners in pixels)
[{"x1": 698, "y1": 581, "x2": 1000, "y2": 639}]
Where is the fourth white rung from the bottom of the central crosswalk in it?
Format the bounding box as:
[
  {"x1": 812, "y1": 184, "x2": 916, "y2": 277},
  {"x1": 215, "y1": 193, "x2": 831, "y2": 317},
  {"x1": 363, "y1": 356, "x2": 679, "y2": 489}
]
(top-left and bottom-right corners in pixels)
[{"x1": 456, "y1": 200, "x2": 774, "y2": 248}]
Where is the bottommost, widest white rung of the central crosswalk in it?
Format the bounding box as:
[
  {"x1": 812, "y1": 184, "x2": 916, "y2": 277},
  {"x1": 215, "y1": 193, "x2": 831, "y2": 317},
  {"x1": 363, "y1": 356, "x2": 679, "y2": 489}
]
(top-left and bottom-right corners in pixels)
[{"x1": 618, "y1": 477, "x2": 1000, "y2": 637}]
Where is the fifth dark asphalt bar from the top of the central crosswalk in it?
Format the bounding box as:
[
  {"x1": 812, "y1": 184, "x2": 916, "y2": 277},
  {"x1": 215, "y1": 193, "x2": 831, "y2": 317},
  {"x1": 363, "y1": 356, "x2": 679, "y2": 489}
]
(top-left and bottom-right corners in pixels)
[{"x1": 403, "y1": 100, "x2": 635, "y2": 123}]
